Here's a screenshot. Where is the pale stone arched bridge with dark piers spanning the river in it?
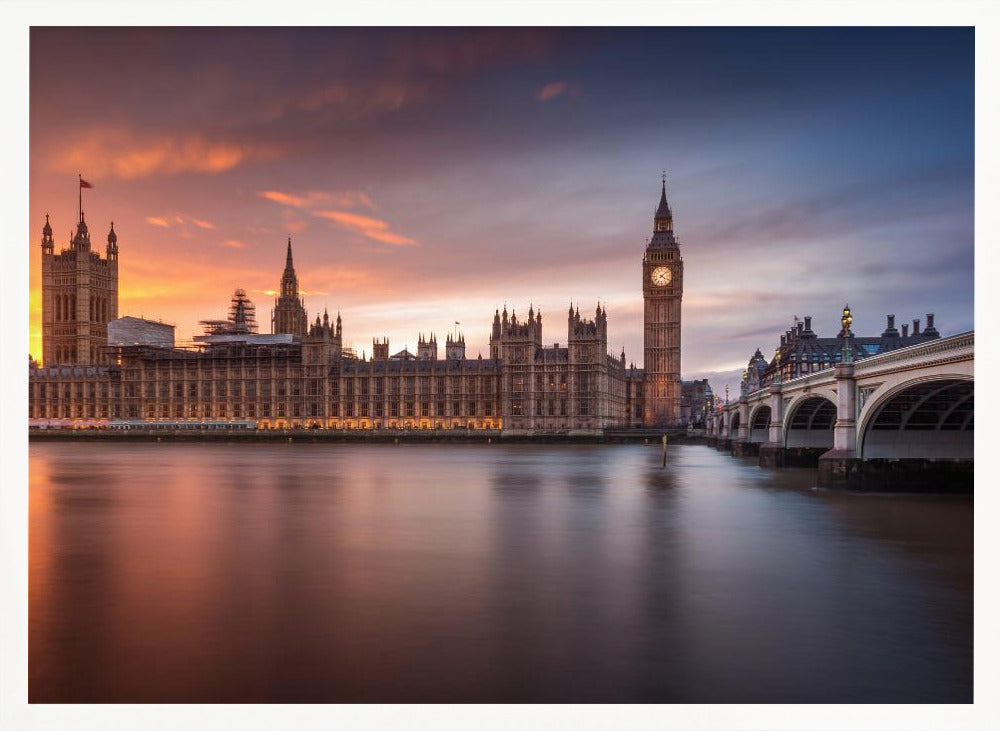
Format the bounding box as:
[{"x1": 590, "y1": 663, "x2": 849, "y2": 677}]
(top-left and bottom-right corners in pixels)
[{"x1": 708, "y1": 331, "x2": 975, "y2": 491}]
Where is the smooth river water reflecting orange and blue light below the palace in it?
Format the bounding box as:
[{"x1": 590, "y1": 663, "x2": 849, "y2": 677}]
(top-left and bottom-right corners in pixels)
[{"x1": 29, "y1": 443, "x2": 973, "y2": 703}]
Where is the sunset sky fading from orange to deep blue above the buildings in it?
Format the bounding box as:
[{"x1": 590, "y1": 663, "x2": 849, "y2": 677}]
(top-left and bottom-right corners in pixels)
[{"x1": 29, "y1": 27, "x2": 975, "y2": 393}]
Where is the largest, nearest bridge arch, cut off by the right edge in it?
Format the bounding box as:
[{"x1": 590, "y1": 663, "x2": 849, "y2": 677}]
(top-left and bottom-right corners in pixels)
[{"x1": 857, "y1": 374, "x2": 975, "y2": 459}]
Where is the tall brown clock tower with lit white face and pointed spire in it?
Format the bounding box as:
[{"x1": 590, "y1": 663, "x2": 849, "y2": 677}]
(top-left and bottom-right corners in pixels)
[{"x1": 642, "y1": 175, "x2": 684, "y2": 427}]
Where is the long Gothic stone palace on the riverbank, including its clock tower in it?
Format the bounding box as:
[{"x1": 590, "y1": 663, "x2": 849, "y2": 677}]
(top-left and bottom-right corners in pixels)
[{"x1": 29, "y1": 183, "x2": 712, "y2": 434}]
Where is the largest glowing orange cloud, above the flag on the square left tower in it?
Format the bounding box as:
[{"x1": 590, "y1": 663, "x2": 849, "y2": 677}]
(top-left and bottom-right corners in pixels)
[{"x1": 49, "y1": 129, "x2": 278, "y2": 180}]
